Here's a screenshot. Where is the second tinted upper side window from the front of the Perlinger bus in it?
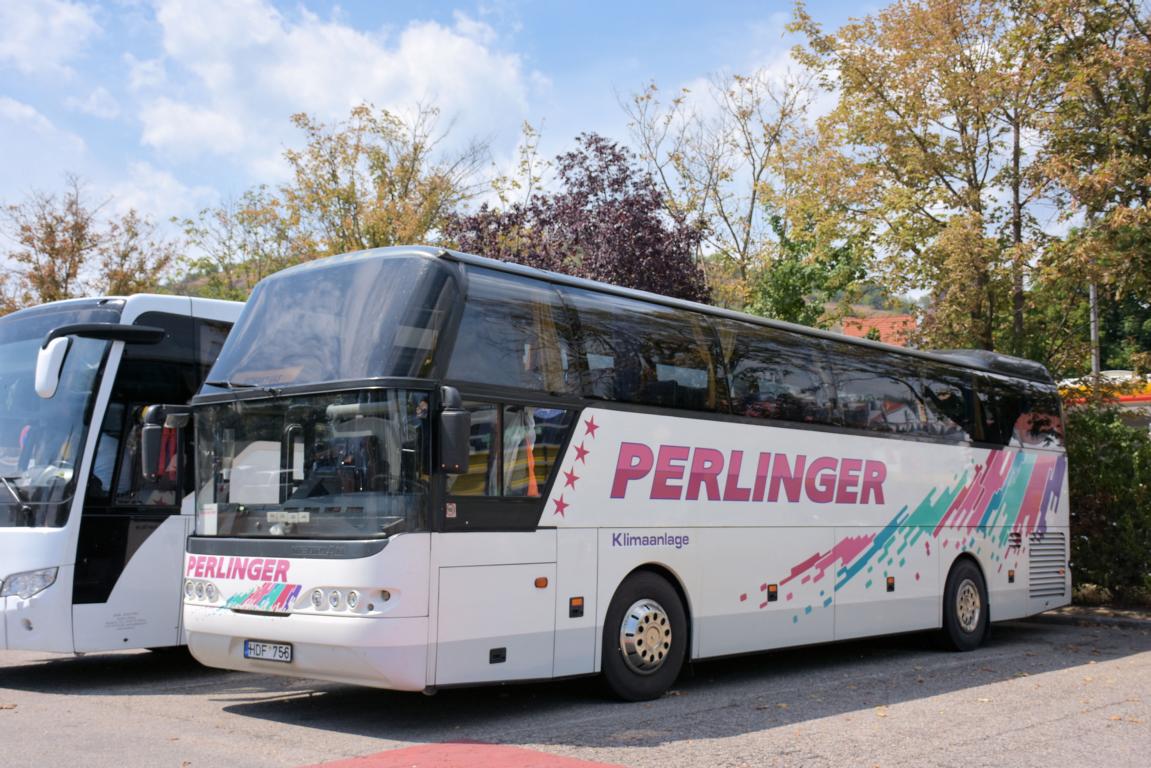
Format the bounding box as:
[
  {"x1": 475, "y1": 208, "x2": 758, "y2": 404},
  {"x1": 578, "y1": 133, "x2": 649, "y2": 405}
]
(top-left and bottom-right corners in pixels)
[{"x1": 563, "y1": 289, "x2": 717, "y2": 411}]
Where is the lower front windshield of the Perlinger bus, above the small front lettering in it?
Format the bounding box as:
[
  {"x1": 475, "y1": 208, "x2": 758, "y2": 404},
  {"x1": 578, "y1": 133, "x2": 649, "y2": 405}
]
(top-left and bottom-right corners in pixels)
[{"x1": 196, "y1": 389, "x2": 430, "y2": 539}]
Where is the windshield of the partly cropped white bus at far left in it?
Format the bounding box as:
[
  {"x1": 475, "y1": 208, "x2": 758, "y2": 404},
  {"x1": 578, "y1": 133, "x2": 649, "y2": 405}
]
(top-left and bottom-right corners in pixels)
[{"x1": 0, "y1": 306, "x2": 120, "y2": 527}]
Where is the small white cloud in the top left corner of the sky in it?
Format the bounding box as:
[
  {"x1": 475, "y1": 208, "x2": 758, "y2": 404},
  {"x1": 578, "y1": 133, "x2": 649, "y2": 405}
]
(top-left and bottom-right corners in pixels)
[{"x1": 0, "y1": 0, "x2": 100, "y2": 76}]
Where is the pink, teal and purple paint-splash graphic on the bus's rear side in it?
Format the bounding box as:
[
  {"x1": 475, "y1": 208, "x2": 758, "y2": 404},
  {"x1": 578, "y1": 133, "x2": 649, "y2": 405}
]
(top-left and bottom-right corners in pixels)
[{"x1": 739, "y1": 450, "x2": 1067, "y2": 622}]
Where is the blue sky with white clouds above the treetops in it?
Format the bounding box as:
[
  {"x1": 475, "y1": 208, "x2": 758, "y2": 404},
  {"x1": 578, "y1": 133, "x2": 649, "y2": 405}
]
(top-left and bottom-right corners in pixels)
[{"x1": 0, "y1": 0, "x2": 868, "y2": 231}]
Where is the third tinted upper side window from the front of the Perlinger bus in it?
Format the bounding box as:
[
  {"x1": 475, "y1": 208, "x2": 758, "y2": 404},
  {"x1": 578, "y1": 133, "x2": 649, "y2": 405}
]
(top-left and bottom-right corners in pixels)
[{"x1": 717, "y1": 320, "x2": 834, "y2": 424}]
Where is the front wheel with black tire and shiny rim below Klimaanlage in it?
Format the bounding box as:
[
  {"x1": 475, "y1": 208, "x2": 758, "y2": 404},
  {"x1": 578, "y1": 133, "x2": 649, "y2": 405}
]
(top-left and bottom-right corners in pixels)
[{"x1": 603, "y1": 571, "x2": 687, "y2": 701}]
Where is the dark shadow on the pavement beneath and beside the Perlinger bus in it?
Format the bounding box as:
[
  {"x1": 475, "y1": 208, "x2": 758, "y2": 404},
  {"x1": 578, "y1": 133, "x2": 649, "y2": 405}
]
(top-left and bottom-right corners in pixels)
[{"x1": 216, "y1": 622, "x2": 1151, "y2": 746}]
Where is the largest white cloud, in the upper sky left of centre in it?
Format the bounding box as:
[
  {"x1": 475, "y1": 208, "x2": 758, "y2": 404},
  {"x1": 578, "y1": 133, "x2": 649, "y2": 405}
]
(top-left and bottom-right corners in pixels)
[{"x1": 142, "y1": 0, "x2": 534, "y2": 172}]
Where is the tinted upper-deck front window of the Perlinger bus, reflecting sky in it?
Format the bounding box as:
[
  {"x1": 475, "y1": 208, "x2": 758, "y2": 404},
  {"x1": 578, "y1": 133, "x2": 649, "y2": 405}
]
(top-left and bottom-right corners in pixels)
[{"x1": 211, "y1": 252, "x2": 458, "y2": 386}]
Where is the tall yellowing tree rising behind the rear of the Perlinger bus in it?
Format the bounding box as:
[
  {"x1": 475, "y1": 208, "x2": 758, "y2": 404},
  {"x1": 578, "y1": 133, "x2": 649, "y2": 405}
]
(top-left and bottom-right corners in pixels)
[{"x1": 793, "y1": 0, "x2": 1054, "y2": 352}]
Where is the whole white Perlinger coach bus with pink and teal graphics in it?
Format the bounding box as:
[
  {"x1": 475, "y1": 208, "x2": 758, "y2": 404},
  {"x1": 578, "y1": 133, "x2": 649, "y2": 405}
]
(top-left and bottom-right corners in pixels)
[{"x1": 184, "y1": 248, "x2": 1070, "y2": 700}]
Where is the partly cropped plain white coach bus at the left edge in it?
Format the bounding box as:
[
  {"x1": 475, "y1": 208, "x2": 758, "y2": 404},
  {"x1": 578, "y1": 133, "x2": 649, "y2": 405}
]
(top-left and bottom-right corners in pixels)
[{"x1": 0, "y1": 295, "x2": 242, "y2": 653}]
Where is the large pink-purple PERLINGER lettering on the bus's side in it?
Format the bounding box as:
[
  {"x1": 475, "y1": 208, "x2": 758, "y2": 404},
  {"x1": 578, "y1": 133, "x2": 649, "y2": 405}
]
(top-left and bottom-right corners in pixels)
[{"x1": 611, "y1": 442, "x2": 887, "y2": 504}]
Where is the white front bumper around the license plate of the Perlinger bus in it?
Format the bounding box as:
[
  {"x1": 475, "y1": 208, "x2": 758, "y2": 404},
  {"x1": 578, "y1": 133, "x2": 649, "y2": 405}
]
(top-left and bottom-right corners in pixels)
[{"x1": 184, "y1": 604, "x2": 428, "y2": 691}]
